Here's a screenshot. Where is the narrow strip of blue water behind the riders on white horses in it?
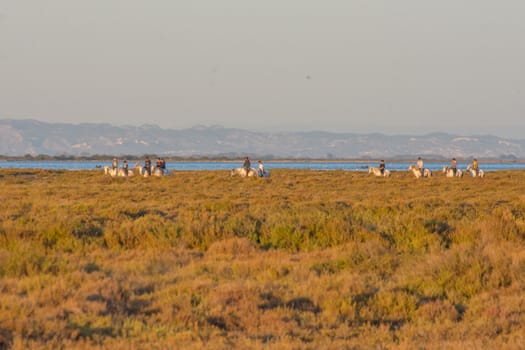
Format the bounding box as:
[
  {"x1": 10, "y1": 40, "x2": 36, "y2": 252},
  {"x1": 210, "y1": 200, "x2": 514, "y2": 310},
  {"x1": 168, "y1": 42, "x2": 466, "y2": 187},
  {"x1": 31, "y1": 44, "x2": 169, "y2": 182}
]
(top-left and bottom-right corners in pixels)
[{"x1": 0, "y1": 161, "x2": 525, "y2": 171}]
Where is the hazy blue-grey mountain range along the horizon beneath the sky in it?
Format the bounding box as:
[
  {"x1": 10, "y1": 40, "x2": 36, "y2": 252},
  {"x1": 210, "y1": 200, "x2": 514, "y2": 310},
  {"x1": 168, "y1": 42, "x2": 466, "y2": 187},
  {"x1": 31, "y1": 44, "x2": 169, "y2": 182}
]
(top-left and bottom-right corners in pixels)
[{"x1": 0, "y1": 119, "x2": 525, "y2": 159}]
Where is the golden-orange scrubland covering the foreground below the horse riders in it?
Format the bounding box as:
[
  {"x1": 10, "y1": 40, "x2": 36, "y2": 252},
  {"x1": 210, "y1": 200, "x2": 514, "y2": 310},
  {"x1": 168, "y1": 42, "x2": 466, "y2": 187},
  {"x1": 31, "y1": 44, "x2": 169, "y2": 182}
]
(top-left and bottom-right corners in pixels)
[{"x1": 0, "y1": 169, "x2": 525, "y2": 350}]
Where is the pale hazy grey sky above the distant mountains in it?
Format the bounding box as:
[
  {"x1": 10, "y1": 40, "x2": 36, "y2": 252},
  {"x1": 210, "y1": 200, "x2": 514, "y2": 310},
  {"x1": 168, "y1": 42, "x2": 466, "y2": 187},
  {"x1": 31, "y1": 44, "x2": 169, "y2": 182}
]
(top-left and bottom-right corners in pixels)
[{"x1": 0, "y1": 0, "x2": 525, "y2": 138}]
